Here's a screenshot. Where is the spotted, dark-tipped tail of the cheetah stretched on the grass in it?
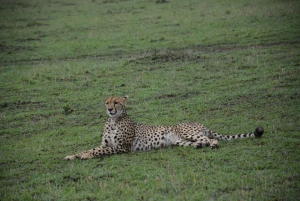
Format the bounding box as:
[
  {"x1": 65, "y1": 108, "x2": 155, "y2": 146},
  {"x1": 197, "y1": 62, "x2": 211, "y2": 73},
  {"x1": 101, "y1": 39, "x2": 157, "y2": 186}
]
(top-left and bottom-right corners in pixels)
[{"x1": 208, "y1": 127, "x2": 264, "y2": 140}]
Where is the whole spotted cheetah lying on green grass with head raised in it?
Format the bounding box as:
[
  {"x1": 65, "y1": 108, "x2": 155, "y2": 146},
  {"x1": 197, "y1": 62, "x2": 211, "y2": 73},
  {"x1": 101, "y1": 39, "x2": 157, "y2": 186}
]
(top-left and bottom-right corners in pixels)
[{"x1": 64, "y1": 96, "x2": 264, "y2": 160}]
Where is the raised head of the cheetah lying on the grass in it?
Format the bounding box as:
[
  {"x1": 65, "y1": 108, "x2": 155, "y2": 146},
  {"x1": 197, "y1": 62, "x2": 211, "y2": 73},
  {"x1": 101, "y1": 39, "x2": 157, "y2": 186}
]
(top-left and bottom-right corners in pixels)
[{"x1": 105, "y1": 96, "x2": 128, "y2": 118}]
